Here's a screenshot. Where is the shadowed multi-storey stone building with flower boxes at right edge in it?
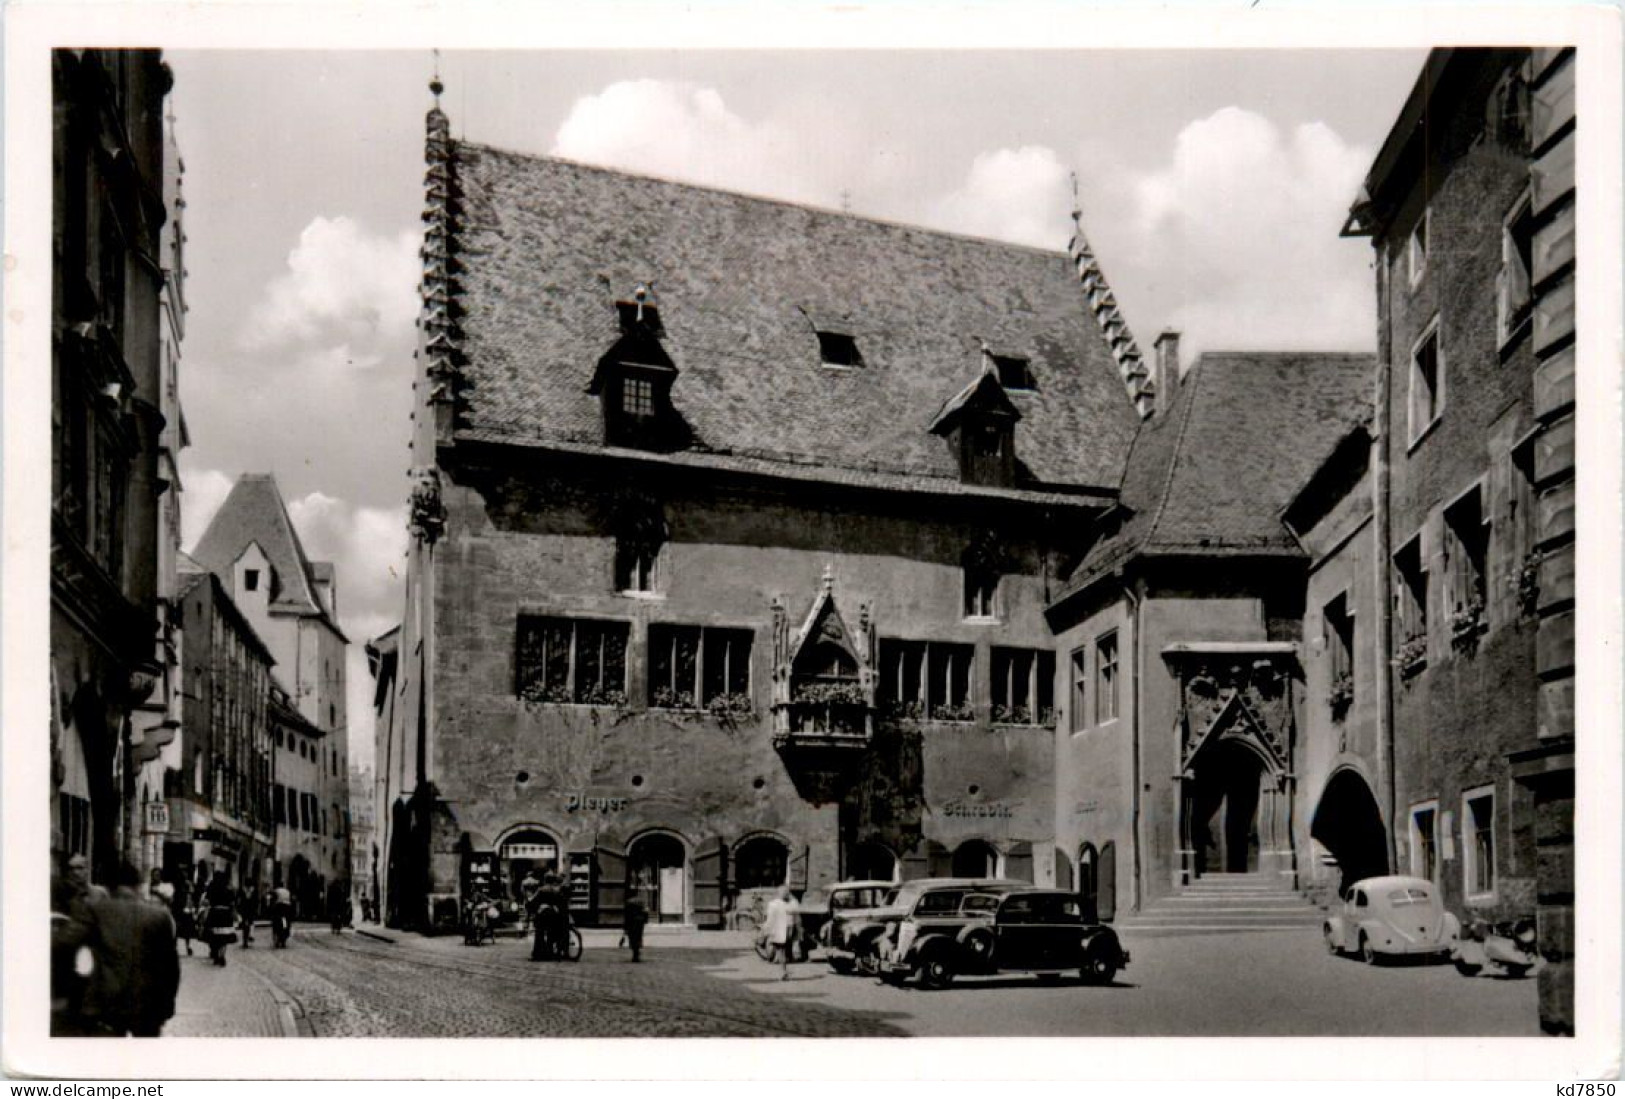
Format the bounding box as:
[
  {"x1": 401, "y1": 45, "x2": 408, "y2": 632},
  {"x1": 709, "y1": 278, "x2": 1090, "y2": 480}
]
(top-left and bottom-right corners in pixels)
[{"x1": 1346, "y1": 49, "x2": 1575, "y2": 1032}]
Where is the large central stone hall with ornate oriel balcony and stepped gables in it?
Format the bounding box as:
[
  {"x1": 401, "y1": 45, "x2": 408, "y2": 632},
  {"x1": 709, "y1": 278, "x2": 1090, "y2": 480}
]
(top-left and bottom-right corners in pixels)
[{"x1": 374, "y1": 92, "x2": 1144, "y2": 927}]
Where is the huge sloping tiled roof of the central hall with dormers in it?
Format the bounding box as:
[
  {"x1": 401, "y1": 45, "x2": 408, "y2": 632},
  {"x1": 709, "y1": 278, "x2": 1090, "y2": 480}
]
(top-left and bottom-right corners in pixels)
[{"x1": 438, "y1": 143, "x2": 1136, "y2": 488}]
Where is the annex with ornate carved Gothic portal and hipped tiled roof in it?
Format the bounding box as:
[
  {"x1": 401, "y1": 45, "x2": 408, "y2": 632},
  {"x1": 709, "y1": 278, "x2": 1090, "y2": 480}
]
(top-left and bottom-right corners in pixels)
[{"x1": 1048, "y1": 343, "x2": 1373, "y2": 919}]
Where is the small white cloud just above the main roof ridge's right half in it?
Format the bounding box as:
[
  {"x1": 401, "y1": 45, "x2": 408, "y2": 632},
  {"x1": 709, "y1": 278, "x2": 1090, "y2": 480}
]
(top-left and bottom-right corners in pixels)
[{"x1": 928, "y1": 145, "x2": 1071, "y2": 250}]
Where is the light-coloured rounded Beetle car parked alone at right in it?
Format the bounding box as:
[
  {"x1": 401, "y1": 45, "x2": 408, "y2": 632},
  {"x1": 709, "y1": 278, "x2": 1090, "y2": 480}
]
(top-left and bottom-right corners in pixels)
[{"x1": 1323, "y1": 875, "x2": 1461, "y2": 966}]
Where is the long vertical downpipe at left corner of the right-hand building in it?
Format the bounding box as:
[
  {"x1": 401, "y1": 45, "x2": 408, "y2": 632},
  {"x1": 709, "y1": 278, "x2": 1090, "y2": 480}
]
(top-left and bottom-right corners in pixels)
[{"x1": 1372, "y1": 239, "x2": 1399, "y2": 871}]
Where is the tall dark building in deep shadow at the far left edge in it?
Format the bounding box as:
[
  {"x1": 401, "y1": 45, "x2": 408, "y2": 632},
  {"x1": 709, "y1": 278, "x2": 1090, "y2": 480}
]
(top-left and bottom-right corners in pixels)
[{"x1": 49, "y1": 49, "x2": 174, "y2": 881}]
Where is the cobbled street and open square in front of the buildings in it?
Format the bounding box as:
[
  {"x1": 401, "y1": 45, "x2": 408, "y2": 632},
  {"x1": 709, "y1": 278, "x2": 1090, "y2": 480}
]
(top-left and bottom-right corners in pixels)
[{"x1": 184, "y1": 928, "x2": 1539, "y2": 1037}]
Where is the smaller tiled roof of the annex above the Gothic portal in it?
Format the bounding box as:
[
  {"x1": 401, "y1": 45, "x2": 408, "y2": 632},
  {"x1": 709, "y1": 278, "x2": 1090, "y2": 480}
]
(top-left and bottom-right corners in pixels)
[{"x1": 1063, "y1": 351, "x2": 1376, "y2": 597}]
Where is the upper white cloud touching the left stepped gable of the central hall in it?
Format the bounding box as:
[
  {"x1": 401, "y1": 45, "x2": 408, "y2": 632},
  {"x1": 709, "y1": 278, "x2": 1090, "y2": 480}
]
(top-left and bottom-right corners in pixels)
[{"x1": 241, "y1": 218, "x2": 421, "y2": 351}]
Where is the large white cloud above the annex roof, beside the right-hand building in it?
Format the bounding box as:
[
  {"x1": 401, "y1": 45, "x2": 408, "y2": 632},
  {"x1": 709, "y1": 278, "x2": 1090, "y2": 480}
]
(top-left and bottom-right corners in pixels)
[{"x1": 1084, "y1": 107, "x2": 1376, "y2": 354}]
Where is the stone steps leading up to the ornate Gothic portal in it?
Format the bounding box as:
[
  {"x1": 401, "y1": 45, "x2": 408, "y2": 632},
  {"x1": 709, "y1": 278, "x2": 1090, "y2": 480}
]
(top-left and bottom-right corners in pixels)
[{"x1": 1115, "y1": 873, "x2": 1323, "y2": 938}]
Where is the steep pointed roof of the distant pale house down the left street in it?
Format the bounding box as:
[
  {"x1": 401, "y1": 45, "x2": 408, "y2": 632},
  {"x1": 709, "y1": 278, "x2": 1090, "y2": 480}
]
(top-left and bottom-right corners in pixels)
[{"x1": 192, "y1": 473, "x2": 327, "y2": 616}]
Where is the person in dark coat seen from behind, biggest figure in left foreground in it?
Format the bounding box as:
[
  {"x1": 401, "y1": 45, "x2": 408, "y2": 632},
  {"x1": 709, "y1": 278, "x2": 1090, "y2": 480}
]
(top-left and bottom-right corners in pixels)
[{"x1": 85, "y1": 862, "x2": 180, "y2": 1037}]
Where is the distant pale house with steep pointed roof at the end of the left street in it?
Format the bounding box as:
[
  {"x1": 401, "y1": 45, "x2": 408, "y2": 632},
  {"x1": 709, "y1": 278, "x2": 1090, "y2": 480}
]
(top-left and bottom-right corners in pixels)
[{"x1": 192, "y1": 473, "x2": 349, "y2": 906}]
